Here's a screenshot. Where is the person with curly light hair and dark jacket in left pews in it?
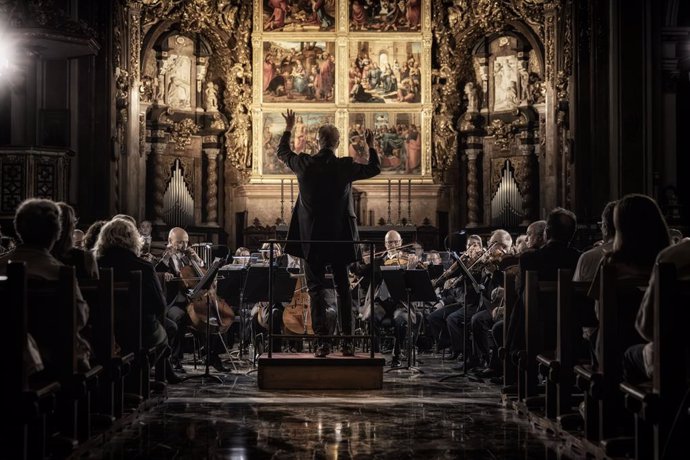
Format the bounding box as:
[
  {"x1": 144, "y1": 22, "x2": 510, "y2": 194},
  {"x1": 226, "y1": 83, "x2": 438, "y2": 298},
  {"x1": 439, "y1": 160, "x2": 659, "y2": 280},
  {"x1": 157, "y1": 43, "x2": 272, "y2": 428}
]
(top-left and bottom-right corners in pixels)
[{"x1": 94, "y1": 218, "x2": 180, "y2": 383}]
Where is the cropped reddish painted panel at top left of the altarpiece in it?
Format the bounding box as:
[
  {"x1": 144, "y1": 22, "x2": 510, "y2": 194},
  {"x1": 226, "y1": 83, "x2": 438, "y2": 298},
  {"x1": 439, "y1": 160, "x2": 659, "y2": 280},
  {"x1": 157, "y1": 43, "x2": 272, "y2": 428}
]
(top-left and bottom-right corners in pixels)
[{"x1": 263, "y1": 0, "x2": 336, "y2": 32}]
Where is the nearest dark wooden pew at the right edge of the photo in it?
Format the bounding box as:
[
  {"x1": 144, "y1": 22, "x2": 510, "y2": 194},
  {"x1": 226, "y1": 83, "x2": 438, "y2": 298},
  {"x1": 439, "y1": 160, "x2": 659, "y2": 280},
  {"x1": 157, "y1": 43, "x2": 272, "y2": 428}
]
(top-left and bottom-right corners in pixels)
[{"x1": 620, "y1": 264, "x2": 690, "y2": 460}]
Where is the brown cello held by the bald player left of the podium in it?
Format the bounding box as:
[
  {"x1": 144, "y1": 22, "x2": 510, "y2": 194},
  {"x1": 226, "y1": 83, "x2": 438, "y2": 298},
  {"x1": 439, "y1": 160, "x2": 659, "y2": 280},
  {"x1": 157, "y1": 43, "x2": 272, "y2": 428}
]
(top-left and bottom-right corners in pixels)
[{"x1": 180, "y1": 255, "x2": 235, "y2": 334}]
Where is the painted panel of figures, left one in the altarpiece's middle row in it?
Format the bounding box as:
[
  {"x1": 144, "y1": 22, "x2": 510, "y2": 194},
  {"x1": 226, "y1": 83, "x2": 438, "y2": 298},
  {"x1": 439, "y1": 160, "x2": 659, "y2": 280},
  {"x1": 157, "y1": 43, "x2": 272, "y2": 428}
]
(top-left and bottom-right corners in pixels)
[{"x1": 262, "y1": 41, "x2": 336, "y2": 103}]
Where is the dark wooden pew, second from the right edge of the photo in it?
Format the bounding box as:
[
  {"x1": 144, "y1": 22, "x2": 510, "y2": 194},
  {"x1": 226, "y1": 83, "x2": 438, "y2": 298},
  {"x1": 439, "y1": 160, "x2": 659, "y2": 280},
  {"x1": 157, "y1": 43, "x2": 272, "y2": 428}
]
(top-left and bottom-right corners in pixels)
[{"x1": 575, "y1": 265, "x2": 649, "y2": 456}]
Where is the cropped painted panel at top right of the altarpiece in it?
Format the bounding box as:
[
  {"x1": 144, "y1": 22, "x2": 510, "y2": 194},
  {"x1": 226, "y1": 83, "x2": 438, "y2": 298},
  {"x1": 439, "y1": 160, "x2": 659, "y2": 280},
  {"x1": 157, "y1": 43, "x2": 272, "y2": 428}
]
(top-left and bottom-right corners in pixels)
[{"x1": 349, "y1": 0, "x2": 422, "y2": 32}]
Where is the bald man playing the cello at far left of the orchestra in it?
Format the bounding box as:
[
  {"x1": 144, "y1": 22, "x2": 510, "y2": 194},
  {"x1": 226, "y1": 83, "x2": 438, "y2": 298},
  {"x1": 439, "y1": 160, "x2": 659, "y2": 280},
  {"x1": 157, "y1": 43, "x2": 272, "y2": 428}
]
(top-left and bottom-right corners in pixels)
[{"x1": 156, "y1": 227, "x2": 226, "y2": 372}]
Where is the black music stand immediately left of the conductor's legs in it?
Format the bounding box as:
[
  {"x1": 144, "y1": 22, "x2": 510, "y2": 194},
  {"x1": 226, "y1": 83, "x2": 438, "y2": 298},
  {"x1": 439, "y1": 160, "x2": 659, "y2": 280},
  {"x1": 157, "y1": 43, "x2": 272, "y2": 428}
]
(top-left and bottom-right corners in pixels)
[{"x1": 242, "y1": 265, "x2": 297, "y2": 364}]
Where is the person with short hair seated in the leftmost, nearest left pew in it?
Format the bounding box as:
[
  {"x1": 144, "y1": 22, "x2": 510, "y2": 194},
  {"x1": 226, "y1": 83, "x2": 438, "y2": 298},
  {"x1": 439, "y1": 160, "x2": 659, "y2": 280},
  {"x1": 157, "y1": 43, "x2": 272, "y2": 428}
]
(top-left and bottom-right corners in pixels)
[{"x1": 0, "y1": 198, "x2": 91, "y2": 372}]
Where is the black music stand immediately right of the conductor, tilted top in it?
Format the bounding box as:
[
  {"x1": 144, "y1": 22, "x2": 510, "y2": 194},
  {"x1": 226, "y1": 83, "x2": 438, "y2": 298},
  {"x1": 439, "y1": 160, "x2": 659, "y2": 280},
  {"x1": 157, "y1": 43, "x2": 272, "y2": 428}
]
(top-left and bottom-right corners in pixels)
[{"x1": 372, "y1": 266, "x2": 436, "y2": 374}]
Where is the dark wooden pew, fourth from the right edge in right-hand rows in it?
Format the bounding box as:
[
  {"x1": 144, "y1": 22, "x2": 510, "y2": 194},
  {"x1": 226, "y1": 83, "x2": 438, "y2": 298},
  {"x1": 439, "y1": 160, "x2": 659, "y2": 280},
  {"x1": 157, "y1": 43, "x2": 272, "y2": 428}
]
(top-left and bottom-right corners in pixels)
[{"x1": 518, "y1": 270, "x2": 557, "y2": 408}]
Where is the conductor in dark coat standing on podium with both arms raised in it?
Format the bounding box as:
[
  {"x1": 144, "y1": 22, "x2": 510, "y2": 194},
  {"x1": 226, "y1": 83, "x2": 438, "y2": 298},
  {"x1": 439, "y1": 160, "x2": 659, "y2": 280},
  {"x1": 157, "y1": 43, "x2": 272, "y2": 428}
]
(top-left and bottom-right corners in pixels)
[{"x1": 278, "y1": 109, "x2": 381, "y2": 358}]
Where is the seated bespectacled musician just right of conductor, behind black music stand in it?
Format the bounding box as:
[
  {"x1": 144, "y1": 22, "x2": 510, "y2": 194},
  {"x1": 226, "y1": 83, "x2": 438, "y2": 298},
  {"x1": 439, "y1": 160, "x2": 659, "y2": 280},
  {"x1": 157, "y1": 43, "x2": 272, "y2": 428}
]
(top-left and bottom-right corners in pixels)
[{"x1": 353, "y1": 230, "x2": 418, "y2": 367}]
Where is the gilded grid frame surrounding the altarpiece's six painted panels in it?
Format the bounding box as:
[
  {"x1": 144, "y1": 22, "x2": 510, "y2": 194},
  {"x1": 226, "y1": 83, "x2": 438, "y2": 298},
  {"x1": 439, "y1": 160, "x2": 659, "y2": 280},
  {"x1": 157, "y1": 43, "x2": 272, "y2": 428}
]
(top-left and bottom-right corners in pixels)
[{"x1": 250, "y1": 0, "x2": 433, "y2": 184}]
